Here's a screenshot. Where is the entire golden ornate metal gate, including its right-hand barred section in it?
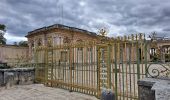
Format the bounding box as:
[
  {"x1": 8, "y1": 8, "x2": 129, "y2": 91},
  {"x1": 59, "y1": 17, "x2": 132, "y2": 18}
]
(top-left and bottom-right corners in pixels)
[{"x1": 36, "y1": 34, "x2": 153, "y2": 100}]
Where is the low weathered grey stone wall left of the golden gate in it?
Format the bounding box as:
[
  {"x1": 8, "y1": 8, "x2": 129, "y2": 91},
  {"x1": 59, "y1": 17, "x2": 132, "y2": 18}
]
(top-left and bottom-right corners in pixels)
[{"x1": 0, "y1": 68, "x2": 35, "y2": 86}]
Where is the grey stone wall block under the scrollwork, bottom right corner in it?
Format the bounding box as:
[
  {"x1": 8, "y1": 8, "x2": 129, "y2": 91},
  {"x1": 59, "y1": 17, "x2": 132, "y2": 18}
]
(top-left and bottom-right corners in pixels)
[{"x1": 138, "y1": 78, "x2": 170, "y2": 100}]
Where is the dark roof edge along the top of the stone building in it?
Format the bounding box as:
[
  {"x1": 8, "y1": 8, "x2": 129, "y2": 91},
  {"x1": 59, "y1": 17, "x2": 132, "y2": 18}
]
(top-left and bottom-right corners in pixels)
[{"x1": 26, "y1": 24, "x2": 97, "y2": 37}]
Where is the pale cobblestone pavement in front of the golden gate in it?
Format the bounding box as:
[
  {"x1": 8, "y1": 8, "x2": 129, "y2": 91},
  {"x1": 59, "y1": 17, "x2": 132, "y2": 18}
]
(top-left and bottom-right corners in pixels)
[{"x1": 0, "y1": 84, "x2": 98, "y2": 100}]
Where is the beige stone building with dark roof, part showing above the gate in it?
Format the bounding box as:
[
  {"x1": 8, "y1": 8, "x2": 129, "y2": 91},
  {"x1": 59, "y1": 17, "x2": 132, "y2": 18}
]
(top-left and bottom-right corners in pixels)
[{"x1": 26, "y1": 24, "x2": 98, "y2": 62}]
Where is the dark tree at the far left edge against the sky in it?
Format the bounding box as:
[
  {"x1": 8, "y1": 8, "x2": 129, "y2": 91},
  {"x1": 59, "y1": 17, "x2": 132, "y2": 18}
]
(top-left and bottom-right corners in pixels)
[{"x1": 0, "y1": 24, "x2": 6, "y2": 44}]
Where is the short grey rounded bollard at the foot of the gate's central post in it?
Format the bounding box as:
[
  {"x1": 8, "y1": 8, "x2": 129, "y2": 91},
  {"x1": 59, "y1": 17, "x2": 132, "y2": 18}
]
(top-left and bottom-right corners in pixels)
[{"x1": 101, "y1": 89, "x2": 116, "y2": 100}]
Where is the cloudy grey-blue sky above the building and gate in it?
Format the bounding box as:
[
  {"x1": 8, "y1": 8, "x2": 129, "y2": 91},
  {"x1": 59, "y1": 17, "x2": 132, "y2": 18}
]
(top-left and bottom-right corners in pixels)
[{"x1": 0, "y1": 0, "x2": 170, "y2": 43}]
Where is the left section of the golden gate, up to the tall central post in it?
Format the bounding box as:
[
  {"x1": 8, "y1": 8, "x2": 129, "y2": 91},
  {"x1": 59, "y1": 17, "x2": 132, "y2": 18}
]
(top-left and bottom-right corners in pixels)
[{"x1": 36, "y1": 42, "x2": 97, "y2": 95}]
